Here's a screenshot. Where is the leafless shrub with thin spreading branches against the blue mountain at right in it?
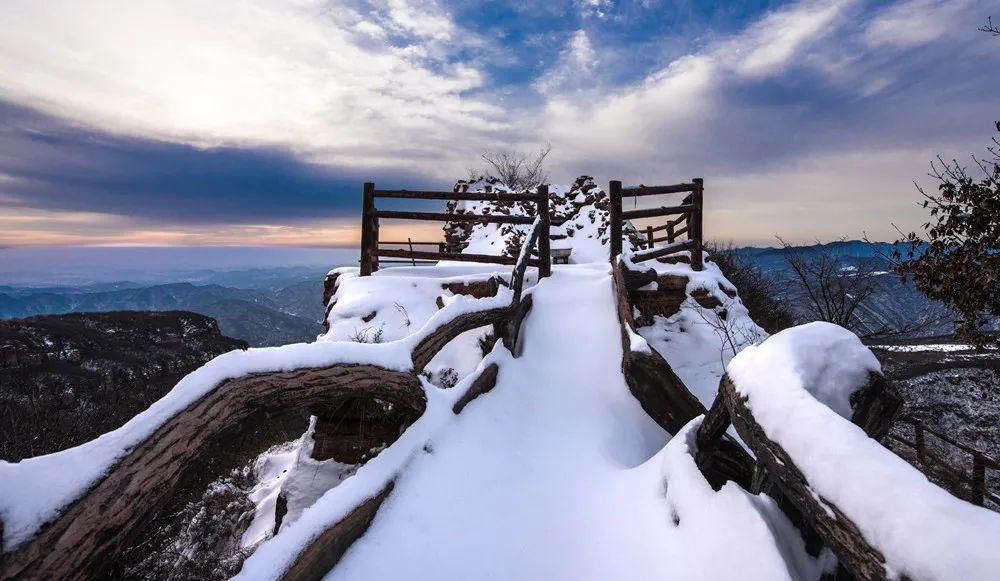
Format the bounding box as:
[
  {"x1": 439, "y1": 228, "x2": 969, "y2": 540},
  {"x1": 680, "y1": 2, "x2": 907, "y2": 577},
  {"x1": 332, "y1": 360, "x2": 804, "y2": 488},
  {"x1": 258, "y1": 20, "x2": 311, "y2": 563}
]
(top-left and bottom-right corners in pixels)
[{"x1": 777, "y1": 236, "x2": 877, "y2": 334}]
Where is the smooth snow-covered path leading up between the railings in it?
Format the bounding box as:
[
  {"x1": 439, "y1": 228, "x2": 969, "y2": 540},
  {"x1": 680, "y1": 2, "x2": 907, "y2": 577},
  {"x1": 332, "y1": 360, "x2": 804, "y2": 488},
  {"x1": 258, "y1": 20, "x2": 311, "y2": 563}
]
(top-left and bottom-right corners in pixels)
[{"x1": 327, "y1": 264, "x2": 812, "y2": 580}]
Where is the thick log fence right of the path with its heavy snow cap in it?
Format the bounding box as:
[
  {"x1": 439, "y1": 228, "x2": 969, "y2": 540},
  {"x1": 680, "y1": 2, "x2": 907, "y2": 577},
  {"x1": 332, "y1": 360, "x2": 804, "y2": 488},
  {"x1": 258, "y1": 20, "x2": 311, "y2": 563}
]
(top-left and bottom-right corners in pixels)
[{"x1": 696, "y1": 323, "x2": 1000, "y2": 579}]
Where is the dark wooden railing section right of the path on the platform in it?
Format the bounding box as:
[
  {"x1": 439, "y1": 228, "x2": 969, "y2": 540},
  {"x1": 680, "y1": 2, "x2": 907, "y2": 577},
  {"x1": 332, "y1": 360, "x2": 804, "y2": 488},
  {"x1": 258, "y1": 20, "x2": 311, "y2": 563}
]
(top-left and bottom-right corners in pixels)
[{"x1": 608, "y1": 178, "x2": 705, "y2": 270}]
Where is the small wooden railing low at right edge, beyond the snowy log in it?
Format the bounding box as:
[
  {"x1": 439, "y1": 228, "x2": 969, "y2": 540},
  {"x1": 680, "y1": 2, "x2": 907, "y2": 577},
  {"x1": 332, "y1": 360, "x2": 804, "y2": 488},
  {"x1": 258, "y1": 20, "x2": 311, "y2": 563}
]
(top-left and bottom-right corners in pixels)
[{"x1": 889, "y1": 417, "x2": 1000, "y2": 510}]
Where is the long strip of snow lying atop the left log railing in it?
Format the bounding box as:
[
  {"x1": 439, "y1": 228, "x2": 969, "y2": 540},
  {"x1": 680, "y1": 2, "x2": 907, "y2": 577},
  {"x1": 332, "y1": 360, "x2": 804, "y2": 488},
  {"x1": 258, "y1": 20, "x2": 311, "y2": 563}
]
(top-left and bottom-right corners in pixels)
[{"x1": 0, "y1": 288, "x2": 512, "y2": 550}]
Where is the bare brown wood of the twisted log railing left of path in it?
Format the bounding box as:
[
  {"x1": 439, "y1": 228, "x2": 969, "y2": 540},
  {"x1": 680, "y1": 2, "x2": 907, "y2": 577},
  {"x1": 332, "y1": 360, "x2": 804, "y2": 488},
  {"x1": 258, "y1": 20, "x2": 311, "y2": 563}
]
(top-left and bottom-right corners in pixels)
[{"x1": 0, "y1": 228, "x2": 548, "y2": 581}]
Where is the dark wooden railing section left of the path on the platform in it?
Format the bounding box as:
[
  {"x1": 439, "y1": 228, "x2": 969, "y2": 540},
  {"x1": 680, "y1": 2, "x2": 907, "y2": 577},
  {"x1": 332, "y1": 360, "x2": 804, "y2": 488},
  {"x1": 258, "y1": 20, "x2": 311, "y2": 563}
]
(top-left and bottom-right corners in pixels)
[{"x1": 361, "y1": 182, "x2": 552, "y2": 277}]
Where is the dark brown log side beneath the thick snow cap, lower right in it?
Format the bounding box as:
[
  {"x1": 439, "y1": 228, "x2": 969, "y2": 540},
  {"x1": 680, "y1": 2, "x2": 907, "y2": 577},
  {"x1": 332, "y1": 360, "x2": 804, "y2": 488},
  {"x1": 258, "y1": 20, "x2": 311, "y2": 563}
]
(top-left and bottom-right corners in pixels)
[{"x1": 719, "y1": 376, "x2": 886, "y2": 579}]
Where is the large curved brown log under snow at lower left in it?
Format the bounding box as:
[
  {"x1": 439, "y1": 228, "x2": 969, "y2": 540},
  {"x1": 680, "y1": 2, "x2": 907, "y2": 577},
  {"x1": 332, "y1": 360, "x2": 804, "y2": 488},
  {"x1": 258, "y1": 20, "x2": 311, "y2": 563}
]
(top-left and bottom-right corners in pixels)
[{"x1": 0, "y1": 365, "x2": 426, "y2": 580}]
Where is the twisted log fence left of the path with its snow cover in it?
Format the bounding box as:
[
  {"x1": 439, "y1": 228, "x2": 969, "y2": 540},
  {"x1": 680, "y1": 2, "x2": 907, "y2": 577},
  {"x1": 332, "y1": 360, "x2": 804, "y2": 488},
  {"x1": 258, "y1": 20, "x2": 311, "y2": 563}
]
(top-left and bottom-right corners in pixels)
[{"x1": 0, "y1": 260, "x2": 542, "y2": 579}]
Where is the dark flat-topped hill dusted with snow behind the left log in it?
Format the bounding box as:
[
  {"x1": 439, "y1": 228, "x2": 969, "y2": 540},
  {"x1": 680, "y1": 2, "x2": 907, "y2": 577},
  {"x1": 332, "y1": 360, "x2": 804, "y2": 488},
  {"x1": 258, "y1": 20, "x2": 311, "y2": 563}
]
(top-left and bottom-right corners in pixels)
[{"x1": 0, "y1": 311, "x2": 247, "y2": 460}]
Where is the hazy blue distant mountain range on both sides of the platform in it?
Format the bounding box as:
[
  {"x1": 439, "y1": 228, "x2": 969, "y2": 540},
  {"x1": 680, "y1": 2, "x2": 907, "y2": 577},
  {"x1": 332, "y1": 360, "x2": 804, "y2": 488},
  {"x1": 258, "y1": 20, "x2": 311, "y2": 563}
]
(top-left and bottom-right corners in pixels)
[{"x1": 0, "y1": 240, "x2": 968, "y2": 346}]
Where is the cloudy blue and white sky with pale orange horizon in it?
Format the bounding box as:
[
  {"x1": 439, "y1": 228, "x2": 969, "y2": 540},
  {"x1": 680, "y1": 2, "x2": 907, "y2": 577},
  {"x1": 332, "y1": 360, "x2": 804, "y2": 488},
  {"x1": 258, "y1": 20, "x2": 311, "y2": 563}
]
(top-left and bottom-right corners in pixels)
[{"x1": 0, "y1": 0, "x2": 1000, "y2": 246}]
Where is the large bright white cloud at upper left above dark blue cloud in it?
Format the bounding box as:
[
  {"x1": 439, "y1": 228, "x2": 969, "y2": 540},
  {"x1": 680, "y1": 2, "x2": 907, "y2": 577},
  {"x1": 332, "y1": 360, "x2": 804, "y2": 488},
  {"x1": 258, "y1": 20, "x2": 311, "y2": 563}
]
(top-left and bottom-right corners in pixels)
[{"x1": 0, "y1": 0, "x2": 504, "y2": 177}]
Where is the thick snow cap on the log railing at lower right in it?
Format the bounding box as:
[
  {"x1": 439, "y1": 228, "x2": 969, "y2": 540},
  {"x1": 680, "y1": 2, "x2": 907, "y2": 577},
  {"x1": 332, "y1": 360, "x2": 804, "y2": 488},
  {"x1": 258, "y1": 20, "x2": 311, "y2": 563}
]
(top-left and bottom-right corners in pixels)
[{"x1": 729, "y1": 323, "x2": 1000, "y2": 580}]
